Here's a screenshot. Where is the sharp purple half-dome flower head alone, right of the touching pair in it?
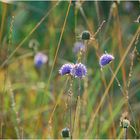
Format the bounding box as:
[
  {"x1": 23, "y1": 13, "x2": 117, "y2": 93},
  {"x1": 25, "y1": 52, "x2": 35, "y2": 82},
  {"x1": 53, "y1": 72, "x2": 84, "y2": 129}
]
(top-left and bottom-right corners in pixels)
[{"x1": 99, "y1": 53, "x2": 114, "y2": 67}]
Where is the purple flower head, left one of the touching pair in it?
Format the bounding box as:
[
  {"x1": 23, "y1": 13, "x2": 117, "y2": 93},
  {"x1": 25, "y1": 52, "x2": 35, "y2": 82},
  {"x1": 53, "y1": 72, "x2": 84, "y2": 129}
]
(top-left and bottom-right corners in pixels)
[{"x1": 59, "y1": 64, "x2": 73, "y2": 75}]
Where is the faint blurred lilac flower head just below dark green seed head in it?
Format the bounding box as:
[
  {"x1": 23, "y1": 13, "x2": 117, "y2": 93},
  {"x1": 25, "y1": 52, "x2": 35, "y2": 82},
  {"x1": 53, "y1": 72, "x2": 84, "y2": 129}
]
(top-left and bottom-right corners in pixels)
[{"x1": 73, "y1": 42, "x2": 85, "y2": 54}]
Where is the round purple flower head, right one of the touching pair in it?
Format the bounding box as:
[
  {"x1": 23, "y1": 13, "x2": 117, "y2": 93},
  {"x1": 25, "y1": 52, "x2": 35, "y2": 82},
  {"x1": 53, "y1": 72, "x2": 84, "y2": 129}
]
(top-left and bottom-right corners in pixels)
[{"x1": 71, "y1": 63, "x2": 87, "y2": 78}]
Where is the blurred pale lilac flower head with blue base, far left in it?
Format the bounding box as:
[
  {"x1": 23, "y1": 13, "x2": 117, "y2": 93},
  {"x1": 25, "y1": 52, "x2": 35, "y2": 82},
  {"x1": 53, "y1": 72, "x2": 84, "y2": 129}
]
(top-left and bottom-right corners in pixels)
[{"x1": 34, "y1": 52, "x2": 48, "y2": 68}]
